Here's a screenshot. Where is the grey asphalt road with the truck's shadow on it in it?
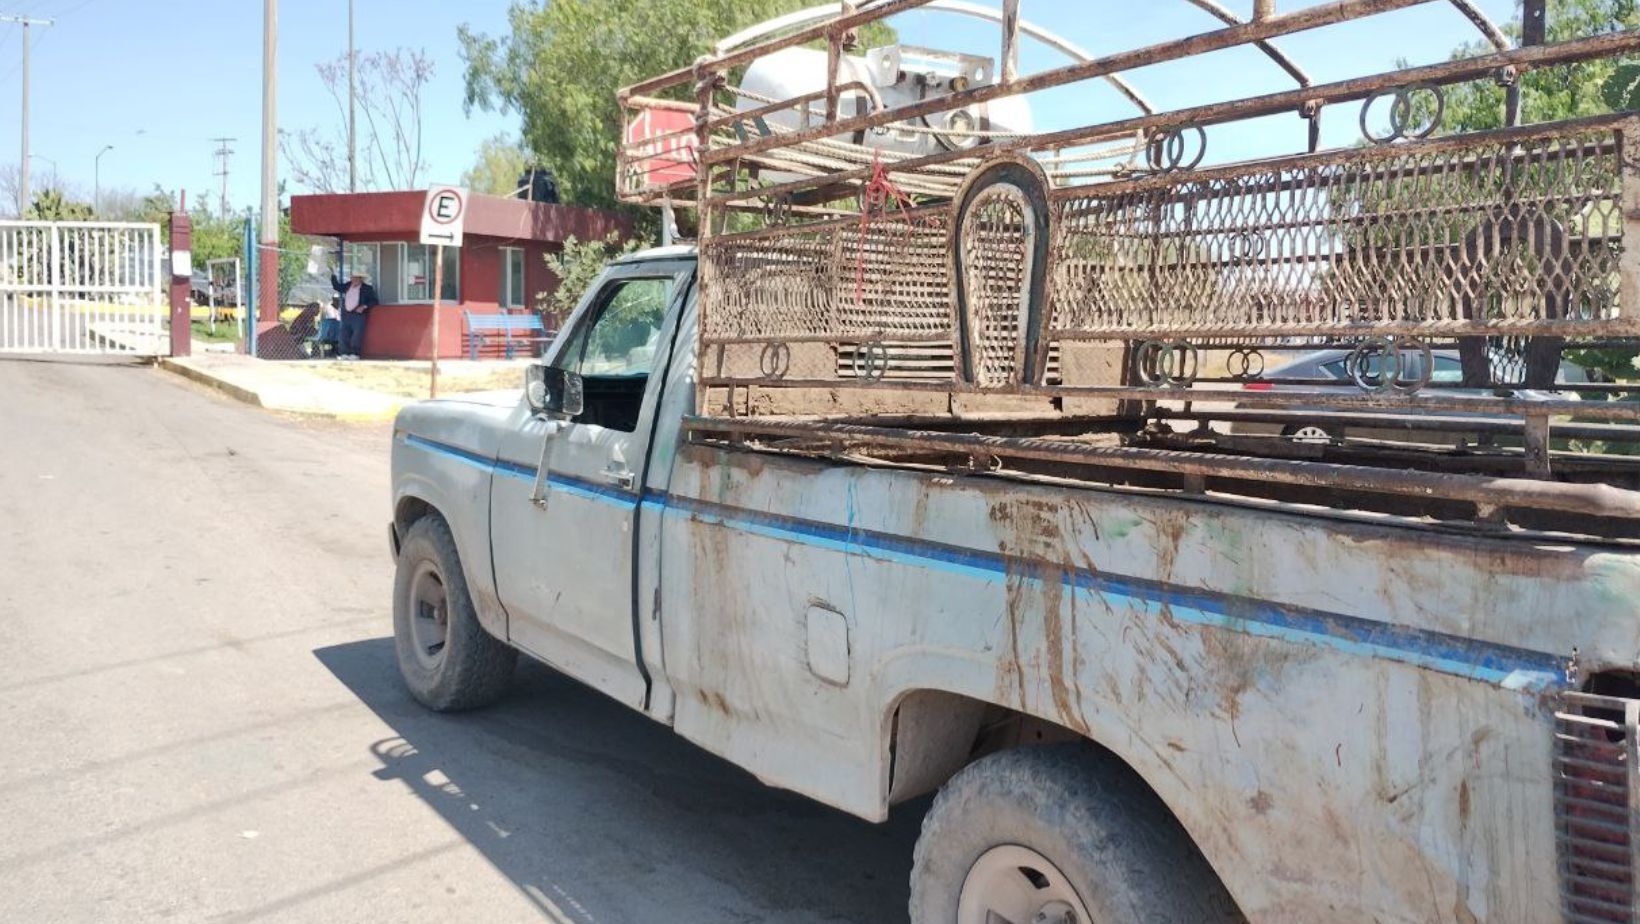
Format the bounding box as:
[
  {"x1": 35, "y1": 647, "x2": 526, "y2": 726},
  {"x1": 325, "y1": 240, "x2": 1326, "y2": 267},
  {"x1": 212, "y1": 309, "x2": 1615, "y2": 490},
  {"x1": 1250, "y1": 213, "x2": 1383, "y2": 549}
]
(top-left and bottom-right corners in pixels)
[{"x1": 0, "y1": 359, "x2": 922, "y2": 924}]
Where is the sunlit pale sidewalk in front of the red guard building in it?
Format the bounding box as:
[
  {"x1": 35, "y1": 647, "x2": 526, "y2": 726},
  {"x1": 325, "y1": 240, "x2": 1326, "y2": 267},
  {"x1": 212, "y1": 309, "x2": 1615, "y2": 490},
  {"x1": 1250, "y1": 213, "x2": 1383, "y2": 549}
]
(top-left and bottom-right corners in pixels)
[{"x1": 159, "y1": 353, "x2": 410, "y2": 420}]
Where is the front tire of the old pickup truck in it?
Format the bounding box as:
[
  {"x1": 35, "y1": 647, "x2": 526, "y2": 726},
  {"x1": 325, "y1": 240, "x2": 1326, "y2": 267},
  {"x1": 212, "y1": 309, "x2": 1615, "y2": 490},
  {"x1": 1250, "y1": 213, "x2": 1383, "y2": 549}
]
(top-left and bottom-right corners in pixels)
[{"x1": 394, "y1": 514, "x2": 518, "y2": 712}]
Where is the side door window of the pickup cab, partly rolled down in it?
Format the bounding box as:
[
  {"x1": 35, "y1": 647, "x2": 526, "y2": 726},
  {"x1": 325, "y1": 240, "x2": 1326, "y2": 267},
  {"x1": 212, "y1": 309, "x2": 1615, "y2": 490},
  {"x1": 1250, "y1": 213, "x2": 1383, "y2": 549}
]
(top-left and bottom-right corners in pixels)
[{"x1": 558, "y1": 276, "x2": 672, "y2": 433}]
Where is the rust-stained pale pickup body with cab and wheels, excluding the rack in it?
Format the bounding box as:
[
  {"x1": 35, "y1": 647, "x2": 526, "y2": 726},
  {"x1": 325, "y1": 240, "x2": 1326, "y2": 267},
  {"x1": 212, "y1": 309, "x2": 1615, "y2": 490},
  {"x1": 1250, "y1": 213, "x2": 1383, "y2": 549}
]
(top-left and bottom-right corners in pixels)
[{"x1": 392, "y1": 248, "x2": 1640, "y2": 924}]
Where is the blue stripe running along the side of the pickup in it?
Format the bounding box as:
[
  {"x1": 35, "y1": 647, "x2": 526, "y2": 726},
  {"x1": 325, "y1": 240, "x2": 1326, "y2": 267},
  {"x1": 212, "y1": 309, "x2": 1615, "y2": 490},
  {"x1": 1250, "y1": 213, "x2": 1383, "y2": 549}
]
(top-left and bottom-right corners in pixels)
[{"x1": 405, "y1": 435, "x2": 1566, "y2": 691}]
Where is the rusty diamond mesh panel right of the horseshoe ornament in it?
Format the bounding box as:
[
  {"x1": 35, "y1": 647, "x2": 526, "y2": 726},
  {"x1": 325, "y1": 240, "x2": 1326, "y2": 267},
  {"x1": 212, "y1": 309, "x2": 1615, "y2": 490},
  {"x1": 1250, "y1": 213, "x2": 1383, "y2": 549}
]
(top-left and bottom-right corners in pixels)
[{"x1": 1048, "y1": 131, "x2": 1640, "y2": 343}]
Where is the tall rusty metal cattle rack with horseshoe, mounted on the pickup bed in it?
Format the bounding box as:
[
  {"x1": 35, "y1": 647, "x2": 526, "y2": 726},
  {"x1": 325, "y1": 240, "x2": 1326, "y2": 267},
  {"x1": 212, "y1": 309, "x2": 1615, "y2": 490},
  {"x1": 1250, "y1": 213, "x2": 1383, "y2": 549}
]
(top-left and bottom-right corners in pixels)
[{"x1": 617, "y1": 0, "x2": 1640, "y2": 521}]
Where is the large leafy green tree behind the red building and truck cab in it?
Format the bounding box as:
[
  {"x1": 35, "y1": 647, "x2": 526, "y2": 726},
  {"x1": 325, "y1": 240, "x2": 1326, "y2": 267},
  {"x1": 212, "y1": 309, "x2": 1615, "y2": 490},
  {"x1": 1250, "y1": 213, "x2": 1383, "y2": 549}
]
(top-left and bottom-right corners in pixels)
[{"x1": 459, "y1": 0, "x2": 892, "y2": 207}]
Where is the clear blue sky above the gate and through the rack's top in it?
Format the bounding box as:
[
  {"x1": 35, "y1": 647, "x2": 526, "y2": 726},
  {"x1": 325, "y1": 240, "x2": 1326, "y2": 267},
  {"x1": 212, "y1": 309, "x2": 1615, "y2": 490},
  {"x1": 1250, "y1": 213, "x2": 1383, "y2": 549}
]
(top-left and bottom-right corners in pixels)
[{"x1": 0, "y1": 0, "x2": 1514, "y2": 207}]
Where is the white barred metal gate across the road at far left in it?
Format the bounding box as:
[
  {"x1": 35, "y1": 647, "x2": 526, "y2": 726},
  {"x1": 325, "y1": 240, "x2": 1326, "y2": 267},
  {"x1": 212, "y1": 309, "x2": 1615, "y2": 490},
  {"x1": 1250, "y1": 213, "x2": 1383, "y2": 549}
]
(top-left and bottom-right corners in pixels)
[{"x1": 0, "y1": 222, "x2": 169, "y2": 355}]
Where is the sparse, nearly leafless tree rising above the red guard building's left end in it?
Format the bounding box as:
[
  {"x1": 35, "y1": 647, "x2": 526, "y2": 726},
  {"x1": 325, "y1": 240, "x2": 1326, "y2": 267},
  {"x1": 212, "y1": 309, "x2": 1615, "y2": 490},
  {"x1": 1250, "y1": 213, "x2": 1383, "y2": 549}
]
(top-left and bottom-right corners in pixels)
[{"x1": 279, "y1": 48, "x2": 435, "y2": 192}]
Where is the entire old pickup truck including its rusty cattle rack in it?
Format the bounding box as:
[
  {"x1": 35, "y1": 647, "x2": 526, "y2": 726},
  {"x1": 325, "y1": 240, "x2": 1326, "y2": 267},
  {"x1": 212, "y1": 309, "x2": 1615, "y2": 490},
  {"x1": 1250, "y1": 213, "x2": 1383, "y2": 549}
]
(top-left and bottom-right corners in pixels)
[{"x1": 392, "y1": 0, "x2": 1640, "y2": 924}]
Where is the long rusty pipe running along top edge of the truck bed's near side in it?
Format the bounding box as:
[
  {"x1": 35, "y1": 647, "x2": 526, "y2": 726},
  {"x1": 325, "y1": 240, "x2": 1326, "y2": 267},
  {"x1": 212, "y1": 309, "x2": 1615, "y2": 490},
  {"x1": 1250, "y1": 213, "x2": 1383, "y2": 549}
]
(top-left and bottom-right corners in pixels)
[{"x1": 684, "y1": 417, "x2": 1640, "y2": 520}]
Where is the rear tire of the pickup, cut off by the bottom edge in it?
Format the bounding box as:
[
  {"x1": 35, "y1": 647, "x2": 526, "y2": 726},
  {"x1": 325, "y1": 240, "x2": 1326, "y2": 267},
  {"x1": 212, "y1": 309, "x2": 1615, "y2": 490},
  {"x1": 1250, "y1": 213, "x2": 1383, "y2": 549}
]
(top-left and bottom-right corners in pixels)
[{"x1": 910, "y1": 743, "x2": 1245, "y2": 924}]
